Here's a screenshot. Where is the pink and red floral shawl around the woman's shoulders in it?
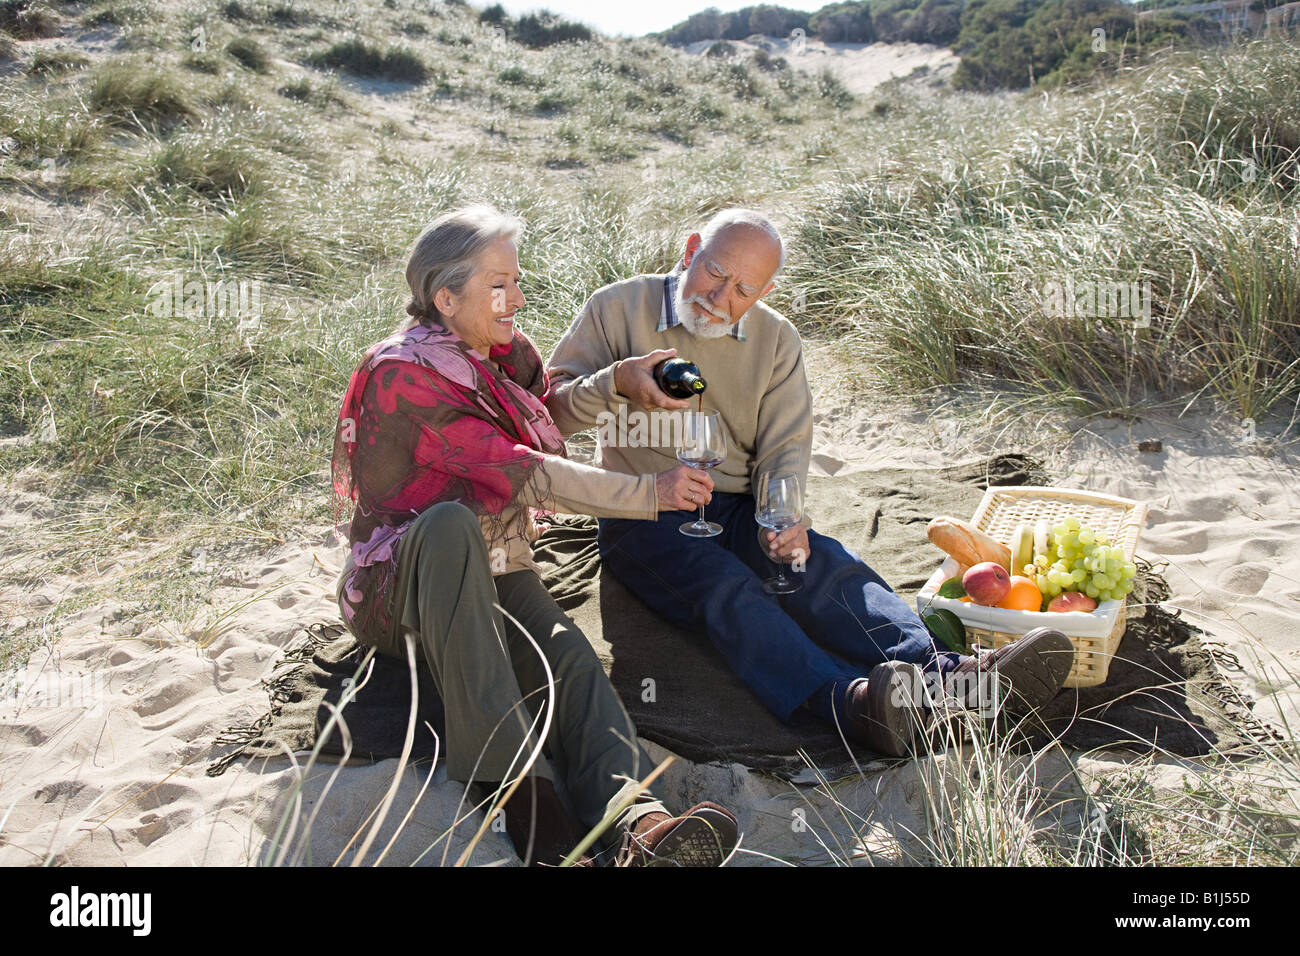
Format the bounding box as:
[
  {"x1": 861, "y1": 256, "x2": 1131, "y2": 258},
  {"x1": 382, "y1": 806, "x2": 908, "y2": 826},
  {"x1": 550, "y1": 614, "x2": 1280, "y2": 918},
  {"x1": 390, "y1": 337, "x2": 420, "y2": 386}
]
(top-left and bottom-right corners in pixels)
[{"x1": 332, "y1": 325, "x2": 564, "y2": 644}]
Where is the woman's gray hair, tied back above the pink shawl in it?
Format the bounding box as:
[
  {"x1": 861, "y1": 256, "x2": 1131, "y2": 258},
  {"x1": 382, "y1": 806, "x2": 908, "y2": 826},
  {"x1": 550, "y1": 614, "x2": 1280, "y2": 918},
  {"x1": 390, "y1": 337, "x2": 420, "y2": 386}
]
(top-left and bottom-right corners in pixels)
[{"x1": 406, "y1": 204, "x2": 524, "y2": 325}]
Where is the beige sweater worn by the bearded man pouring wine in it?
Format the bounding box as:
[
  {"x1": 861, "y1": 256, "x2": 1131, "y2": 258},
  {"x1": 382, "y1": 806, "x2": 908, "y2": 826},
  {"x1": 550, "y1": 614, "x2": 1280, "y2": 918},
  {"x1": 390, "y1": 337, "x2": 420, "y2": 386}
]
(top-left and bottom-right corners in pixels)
[{"x1": 546, "y1": 274, "x2": 813, "y2": 492}]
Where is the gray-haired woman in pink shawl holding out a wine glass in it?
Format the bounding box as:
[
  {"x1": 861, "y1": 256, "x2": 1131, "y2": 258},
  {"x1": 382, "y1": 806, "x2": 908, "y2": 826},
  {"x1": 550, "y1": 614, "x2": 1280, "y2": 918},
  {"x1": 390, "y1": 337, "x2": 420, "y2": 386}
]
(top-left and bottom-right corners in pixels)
[{"x1": 333, "y1": 206, "x2": 737, "y2": 865}]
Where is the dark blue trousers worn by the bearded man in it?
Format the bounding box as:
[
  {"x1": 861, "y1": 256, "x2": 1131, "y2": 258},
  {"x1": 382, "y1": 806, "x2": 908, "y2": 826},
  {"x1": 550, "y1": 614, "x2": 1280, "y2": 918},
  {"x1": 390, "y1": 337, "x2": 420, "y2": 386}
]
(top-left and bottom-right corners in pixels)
[{"x1": 598, "y1": 492, "x2": 961, "y2": 721}]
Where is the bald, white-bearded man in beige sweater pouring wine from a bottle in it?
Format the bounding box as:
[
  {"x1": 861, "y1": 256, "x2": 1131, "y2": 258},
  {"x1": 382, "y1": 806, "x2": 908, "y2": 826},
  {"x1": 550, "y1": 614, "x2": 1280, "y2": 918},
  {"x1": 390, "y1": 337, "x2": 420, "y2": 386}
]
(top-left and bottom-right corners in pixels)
[{"x1": 546, "y1": 209, "x2": 1073, "y2": 756}]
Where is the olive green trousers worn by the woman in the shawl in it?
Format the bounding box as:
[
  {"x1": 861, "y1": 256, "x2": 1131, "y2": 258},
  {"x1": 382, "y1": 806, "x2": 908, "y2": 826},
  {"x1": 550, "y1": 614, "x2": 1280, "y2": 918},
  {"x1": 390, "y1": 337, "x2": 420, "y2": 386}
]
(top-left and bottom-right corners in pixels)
[{"x1": 361, "y1": 502, "x2": 667, "y2": 829}]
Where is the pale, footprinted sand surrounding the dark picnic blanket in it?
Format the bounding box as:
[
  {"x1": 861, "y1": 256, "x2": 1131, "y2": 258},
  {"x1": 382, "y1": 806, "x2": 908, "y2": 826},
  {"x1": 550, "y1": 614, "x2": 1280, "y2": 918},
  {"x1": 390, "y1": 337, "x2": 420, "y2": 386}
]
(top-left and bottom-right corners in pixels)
[{"x1": 0, "y1": 348, "x2": 1300, "y2": 866}]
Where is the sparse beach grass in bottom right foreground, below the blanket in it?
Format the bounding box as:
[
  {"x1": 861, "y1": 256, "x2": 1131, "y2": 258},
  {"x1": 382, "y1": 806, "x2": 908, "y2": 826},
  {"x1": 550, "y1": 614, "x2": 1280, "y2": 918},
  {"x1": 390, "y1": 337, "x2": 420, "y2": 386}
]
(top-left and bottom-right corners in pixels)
[{"x1": 764, "y1": 639, "x2": 1300, "y2": 866}]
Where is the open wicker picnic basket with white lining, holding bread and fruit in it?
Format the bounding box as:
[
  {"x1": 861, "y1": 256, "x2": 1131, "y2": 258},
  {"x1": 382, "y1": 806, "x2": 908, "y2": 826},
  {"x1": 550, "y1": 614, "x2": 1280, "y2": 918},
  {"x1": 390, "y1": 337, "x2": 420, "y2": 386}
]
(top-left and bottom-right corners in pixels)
[{"x1": 917, "y1": 486, "x2": 1147, "y2": 687}]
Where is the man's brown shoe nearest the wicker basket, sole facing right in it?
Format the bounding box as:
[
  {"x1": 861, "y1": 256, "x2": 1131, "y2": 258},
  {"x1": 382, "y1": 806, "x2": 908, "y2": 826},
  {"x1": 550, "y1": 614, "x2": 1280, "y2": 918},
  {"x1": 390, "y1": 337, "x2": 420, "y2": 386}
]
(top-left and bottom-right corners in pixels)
[{"x1": 944, "y1": 627, "x2": 1074, "y2": 715}]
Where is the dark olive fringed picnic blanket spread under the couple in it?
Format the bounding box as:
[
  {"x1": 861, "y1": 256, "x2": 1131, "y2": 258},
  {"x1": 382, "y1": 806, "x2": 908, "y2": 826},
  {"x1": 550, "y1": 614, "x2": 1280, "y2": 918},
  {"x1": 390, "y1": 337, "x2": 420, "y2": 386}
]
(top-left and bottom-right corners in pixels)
[{"x1": 208, "y1": 455, "x2": 1277, "y2": 775}]
